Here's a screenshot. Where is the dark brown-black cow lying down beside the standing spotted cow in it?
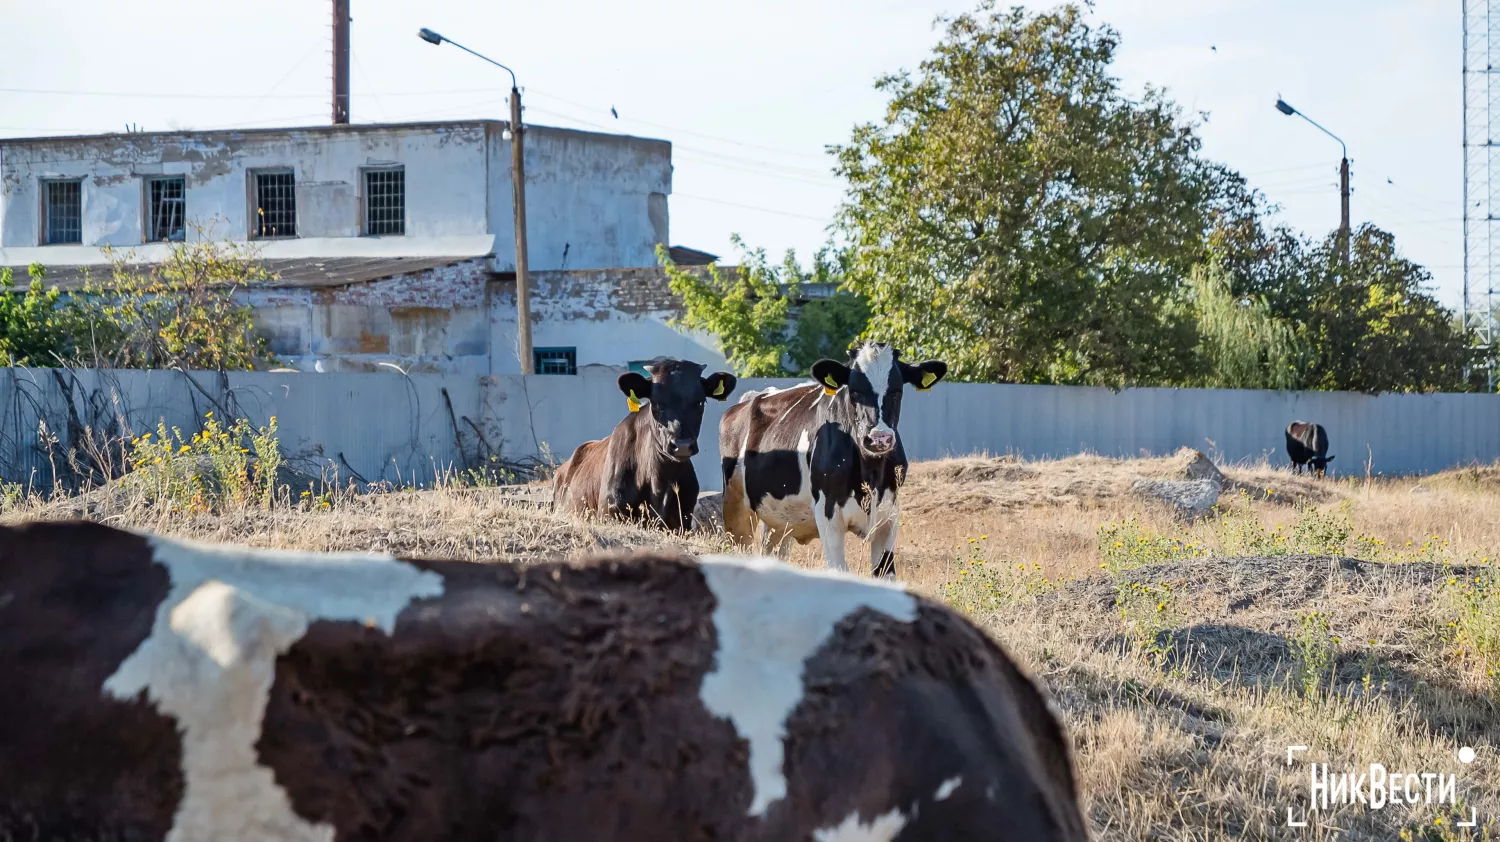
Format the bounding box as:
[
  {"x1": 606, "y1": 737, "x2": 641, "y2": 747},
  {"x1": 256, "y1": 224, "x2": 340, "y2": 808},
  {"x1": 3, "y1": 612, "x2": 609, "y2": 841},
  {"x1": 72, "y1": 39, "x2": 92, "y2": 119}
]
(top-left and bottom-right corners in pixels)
[{"x1": 552, "y1": 359, "x2": 735, "y2": 531}]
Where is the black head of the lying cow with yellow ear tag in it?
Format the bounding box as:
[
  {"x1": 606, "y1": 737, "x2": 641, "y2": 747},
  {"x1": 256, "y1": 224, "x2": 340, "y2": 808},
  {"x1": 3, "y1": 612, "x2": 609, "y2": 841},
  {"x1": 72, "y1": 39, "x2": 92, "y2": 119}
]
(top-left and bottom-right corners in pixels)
[{"x1": 620, "y1": 359, "x2": 735, "y2": 462}]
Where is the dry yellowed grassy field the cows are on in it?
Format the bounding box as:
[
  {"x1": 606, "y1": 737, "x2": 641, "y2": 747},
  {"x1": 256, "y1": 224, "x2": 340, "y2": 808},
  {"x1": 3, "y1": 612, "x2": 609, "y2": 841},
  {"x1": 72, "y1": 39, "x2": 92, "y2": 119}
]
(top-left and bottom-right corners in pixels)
[{"x1": 0, "y1": 456, "x2": 1500, "y2": 840}]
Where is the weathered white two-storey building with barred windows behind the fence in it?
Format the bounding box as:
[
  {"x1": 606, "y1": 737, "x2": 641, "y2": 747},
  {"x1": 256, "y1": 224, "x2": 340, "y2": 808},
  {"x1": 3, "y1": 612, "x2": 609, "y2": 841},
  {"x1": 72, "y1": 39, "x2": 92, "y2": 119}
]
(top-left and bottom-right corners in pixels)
[{"x1": 0, "y1": 120, "x2": 723, "y2": 374}]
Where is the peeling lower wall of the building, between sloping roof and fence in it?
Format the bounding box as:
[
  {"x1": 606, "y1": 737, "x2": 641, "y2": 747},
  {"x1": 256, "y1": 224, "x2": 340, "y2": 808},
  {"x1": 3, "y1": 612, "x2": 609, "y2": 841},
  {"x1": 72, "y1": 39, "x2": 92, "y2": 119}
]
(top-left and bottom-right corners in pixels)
[{"x1": 242, "y1": 258, "x2": 725, "y2": 375}]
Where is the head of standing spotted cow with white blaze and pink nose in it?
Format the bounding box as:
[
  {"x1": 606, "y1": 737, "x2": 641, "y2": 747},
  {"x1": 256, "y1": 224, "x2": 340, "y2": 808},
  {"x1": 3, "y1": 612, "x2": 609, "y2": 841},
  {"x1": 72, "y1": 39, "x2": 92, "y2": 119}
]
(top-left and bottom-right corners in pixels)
[{"x1": 812, "y1": 342, "x2": 948, "y2": 456}]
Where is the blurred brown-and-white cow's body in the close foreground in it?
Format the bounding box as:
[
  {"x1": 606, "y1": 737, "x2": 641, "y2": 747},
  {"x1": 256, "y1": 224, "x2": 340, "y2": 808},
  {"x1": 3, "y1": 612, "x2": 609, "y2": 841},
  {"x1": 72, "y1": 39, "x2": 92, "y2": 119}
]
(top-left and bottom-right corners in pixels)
[{"x1": 0, "y1": 521, "x2": 1088, "y2": 842}]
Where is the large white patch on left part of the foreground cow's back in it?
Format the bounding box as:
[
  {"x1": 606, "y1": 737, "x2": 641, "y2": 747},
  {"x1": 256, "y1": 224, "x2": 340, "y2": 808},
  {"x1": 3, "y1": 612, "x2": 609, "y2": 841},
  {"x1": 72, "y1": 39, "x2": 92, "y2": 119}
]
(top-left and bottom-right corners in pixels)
[{"x1": 104, "y1": 536, "x2": 443, "y2": 842}]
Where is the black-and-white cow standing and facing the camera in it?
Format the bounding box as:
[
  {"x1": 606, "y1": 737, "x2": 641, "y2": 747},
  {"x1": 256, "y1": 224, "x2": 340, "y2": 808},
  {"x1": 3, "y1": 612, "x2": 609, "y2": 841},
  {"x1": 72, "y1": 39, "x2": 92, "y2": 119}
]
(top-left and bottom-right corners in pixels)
[{"x1": 719, "y1": 342, "x2": 948, "y2": 576}]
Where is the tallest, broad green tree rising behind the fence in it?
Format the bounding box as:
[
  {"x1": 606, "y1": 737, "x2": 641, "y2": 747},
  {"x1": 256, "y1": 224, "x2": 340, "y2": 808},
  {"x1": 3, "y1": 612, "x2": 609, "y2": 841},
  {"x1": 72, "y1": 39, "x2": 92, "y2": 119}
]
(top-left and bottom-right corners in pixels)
[{"x1": 837, "y1": 0, "x2": 1254, "y2": 386}]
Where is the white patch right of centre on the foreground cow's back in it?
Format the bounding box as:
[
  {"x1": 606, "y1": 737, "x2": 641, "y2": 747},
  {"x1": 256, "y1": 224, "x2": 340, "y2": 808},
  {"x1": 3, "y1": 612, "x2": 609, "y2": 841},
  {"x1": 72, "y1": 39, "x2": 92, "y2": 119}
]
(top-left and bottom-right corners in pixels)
[{"x1": 699, "y1": 555, "x2": 917, "y2": 815}]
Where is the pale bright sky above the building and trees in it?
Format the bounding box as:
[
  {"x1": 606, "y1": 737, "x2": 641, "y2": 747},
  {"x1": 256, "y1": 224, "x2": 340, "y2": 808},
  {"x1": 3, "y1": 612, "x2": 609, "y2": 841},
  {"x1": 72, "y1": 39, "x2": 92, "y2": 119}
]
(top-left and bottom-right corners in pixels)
[{"x1": 0, "y1": 0, "x2": 1463, "y2": 306}]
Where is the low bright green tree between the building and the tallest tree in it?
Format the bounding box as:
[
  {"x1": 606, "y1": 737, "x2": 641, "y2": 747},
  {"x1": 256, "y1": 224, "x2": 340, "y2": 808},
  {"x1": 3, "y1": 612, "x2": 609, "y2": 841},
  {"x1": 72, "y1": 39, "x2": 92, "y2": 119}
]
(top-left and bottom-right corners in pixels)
[{"x1": 657, "y1": 236, "x2": 870, "y2": 377}]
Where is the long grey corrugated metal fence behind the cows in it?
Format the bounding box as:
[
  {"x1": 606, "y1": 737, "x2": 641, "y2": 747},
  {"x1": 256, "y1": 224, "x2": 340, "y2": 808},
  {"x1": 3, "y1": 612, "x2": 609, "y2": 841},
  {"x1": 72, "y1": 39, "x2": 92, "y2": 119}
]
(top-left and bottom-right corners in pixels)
[{"x1": 0, "y1": 366, "x2": 1500, "y2": 489}]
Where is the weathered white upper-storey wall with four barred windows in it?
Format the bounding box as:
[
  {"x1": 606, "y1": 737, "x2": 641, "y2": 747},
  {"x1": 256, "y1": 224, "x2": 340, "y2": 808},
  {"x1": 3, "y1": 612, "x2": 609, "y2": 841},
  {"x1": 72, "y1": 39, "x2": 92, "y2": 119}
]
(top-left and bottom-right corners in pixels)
[{"x1": 0, "y1": 120, "x2": 672, "y2": 270}]
